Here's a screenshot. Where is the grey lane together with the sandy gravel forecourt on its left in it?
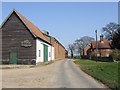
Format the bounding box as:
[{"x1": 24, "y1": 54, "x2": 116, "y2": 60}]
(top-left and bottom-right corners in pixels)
[{"x1": 2, "y1": 60, "x2": 106, "y2": 88}]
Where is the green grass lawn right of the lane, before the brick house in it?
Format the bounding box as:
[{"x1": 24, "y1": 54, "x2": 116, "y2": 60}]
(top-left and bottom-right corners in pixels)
[{"x1": 74, "y1": 59, "x2": 120, "y2": 90}]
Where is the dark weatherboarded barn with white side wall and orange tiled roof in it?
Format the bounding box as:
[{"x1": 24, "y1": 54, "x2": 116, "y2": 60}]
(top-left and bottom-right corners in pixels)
[{"x1": 1, "y1": 10, "x2": 65, "y2": 64}]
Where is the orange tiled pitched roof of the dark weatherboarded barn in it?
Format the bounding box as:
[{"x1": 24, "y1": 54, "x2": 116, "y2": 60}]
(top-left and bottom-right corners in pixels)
[{"x1": 2, "y1": 9, "x2": 50, "y2": 44}]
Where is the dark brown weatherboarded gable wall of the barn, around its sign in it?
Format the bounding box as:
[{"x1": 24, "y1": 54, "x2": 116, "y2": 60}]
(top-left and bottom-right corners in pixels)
[{"x1": 2, "y1": 13, "x2": 36, "y2": 64}]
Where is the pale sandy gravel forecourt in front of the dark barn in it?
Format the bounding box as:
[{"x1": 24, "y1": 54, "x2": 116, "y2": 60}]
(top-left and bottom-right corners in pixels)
[{"x1": 2, "y1": 63, "x2": 55, "y2": 88}]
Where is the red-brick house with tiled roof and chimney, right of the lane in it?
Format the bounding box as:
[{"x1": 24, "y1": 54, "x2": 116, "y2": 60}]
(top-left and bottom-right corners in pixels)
[{"x1": 83, "y1": 35, "x2": 112, "y2": 59}]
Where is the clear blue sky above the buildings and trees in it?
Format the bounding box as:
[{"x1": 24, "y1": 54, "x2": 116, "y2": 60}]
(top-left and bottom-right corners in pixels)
[{"x1": 2, "y1": 2, "x2": 118, "y2": 49}]
